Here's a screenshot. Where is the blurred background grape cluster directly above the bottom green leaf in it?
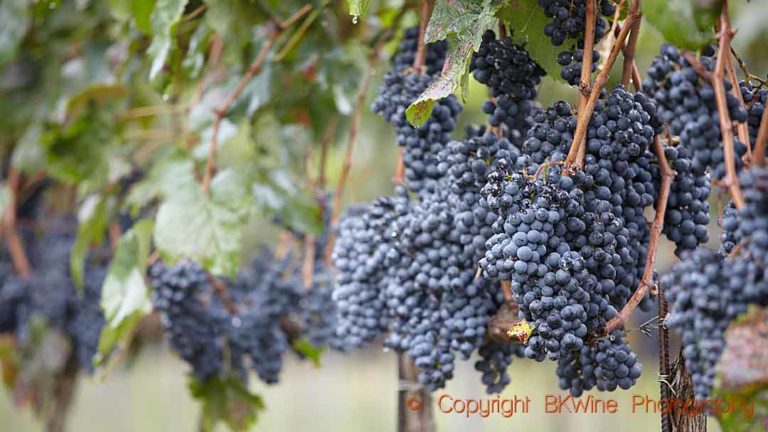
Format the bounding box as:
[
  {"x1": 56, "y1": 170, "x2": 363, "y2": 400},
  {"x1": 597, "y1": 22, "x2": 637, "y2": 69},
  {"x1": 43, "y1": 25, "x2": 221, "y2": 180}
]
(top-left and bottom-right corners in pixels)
[{"x1": 149, "y1": 243, "x2": 336, "y2": 384}]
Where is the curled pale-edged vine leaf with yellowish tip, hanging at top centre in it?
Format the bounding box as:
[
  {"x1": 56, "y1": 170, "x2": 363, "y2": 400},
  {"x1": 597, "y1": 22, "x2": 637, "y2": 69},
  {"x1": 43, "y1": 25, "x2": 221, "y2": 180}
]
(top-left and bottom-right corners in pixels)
[{"x1": 405, "y1": 0, "x2": 499, "y2": 126}]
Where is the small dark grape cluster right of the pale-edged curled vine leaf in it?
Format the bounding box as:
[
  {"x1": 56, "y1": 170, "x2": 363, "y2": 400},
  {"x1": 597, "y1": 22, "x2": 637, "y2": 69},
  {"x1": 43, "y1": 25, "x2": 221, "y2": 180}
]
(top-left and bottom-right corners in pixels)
[{"x1": 470, "y1": 30, "x2": 546, "y2": 140}]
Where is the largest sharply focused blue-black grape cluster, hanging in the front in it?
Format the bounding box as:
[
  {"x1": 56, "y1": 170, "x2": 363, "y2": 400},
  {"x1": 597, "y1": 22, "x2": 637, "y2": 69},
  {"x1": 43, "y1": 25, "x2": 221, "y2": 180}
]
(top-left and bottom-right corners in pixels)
[{"x1": 479, "y1": 86, "x2": 660, "y2": 394}]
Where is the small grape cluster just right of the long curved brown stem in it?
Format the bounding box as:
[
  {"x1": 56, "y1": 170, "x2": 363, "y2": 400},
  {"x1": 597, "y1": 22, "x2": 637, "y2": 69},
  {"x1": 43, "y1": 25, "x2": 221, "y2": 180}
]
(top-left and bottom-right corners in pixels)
[{"x1": 662, "y1": 145, "x2": 711, "y2": 256}]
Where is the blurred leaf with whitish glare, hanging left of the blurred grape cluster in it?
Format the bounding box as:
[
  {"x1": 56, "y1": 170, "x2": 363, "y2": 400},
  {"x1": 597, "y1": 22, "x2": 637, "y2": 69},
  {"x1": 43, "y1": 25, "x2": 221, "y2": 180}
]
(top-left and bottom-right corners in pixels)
[{"x1": 95, "y1": 219, "x2": 154, "y2": 366}]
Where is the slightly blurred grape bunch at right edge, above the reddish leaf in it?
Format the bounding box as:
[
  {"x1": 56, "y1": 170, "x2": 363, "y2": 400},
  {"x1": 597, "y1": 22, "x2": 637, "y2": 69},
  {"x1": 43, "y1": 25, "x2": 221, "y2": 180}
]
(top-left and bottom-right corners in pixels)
[{"x1": 661, "y1": 167, "x2": 768, "y2": 399}]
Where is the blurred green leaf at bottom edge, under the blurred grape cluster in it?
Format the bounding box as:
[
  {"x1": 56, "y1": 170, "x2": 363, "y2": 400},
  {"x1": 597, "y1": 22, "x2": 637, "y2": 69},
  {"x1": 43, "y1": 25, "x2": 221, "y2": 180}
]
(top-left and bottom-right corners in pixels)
[{"x1": 189, "y1": 377, "x2": 264, "y2": 431}]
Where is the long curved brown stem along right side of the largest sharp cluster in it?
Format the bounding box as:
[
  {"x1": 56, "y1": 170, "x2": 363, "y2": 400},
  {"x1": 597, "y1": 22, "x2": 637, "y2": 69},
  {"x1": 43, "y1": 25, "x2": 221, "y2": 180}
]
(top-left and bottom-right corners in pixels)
[{"x1": 605, "y1": 136, "x2": 675, "y2": 334}]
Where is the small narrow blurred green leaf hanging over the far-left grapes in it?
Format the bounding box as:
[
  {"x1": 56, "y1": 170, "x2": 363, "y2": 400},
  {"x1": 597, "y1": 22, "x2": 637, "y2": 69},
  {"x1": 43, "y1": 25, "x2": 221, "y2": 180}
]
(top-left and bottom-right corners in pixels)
[{"x1": 69, "y1": 194, "x2": 107, "y2": 290}]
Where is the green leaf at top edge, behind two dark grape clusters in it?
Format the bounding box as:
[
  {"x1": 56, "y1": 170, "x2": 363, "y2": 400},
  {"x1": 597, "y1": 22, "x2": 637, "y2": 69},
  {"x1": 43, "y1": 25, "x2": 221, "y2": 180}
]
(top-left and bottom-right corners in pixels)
[{"x1": 498, "y1": 0, "x2": 565, "y2": 81}]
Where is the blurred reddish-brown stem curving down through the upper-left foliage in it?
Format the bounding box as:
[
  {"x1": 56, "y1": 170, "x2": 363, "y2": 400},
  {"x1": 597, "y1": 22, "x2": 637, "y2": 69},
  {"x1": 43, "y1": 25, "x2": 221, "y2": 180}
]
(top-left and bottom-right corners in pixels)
[{"x1": 202, "y1": 4, "x2": 313, "y2": 193}]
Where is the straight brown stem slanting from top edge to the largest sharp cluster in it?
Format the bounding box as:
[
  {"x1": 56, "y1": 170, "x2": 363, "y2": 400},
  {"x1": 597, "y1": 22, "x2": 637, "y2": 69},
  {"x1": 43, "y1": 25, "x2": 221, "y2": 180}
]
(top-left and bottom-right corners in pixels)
[{"x1": 565, "y1": 0, "x2": 642, "y2": 167}]
